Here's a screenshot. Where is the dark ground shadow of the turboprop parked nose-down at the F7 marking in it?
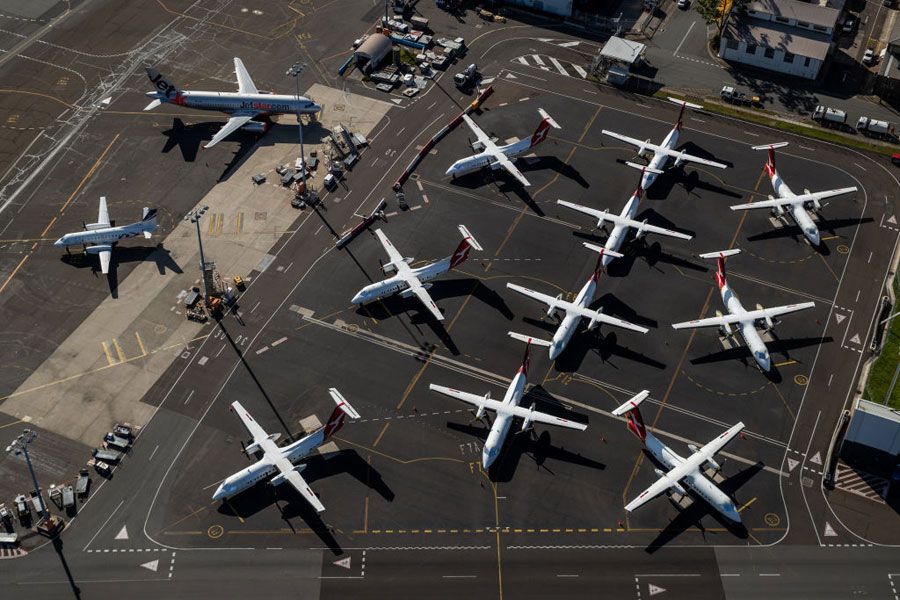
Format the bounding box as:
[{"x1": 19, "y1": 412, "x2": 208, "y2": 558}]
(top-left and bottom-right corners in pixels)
[{"x1": 447, "y1": 386, "x2": 606, "y2": 483}]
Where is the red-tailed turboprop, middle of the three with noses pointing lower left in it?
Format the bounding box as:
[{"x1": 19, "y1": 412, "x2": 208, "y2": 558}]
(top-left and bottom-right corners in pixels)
[{"x1": 351, "y1": 225, "x2": 483, "y2": 321}]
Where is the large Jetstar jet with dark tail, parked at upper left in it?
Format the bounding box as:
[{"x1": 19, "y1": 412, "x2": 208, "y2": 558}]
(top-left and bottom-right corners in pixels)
[{"x1": 144, "y1": 58, "x2": 322, "y2": 148}]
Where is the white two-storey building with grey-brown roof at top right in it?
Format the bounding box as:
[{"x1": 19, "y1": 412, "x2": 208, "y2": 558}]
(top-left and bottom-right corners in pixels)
[{"x1": 719, "y1": 0, "x2": 840, "y2": 79}]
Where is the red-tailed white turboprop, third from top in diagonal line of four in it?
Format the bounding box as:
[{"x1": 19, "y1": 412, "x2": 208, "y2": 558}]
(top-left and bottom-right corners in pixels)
[{"x1": 506, "y1": 242, "x2": 649, "y2": 360}]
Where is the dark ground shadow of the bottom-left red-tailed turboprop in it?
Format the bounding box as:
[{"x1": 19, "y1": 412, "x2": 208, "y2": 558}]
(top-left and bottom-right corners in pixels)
[{"x1": 218, "y1": 450, "x2": 395, "y2": 555}]
